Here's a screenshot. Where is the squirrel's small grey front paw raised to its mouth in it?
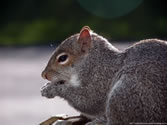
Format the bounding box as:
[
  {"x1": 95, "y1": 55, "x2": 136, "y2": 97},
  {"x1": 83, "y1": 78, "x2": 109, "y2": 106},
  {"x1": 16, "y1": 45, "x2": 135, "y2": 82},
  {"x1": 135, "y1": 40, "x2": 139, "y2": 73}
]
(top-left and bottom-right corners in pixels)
[{"x1": 41, "y1": 83, "x2": 55, "y2": 98}]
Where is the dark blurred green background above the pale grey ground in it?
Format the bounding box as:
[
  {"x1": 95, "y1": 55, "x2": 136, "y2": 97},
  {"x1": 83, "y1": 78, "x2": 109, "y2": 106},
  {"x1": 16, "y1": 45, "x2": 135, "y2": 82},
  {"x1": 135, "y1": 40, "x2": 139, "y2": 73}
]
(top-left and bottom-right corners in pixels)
[{"x1": 0, "y1": 0, "x2": 167, "y2": 46}]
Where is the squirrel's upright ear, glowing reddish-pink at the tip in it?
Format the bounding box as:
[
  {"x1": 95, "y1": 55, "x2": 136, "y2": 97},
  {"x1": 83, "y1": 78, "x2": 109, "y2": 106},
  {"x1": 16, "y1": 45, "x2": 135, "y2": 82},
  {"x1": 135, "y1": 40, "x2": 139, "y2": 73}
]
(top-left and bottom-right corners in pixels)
[{"x1": 78, "y1": 26, "x2": 91, "y2": 52}]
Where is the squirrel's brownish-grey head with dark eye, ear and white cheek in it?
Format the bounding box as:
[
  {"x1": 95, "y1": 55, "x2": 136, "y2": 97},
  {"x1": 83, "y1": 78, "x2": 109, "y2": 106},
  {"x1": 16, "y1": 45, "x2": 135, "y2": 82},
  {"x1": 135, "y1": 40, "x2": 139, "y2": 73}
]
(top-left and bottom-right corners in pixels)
[{"x1": 42, "y1": 26, "x2": 92, "y2": 85}]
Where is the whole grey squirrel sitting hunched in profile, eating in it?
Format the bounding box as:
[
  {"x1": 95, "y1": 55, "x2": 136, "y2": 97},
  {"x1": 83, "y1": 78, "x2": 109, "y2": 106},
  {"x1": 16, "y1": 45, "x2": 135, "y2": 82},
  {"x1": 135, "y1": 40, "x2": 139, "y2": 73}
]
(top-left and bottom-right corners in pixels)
[{"x1": 41, "y1": 26, "x2": 167, "y2": 125}]
